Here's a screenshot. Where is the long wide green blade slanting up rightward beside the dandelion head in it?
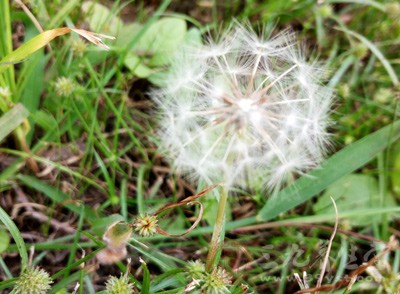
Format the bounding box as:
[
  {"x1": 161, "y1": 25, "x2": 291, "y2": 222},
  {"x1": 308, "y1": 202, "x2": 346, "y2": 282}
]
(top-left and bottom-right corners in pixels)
[{"x1": 257, "y1": 121, "x2": 400, "y2": 222}]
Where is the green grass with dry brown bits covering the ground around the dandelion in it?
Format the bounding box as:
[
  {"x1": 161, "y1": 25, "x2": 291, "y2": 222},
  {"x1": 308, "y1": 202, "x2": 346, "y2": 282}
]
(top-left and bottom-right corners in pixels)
[{"x1": 0, "y1": 0, "x2": 400, "y2": 293}]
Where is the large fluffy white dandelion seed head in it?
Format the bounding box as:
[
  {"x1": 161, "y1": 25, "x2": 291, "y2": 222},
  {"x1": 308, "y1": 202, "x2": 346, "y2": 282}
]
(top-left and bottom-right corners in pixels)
[{"x1": 152, "y1": 26, "x2": 333, "y2": 188}]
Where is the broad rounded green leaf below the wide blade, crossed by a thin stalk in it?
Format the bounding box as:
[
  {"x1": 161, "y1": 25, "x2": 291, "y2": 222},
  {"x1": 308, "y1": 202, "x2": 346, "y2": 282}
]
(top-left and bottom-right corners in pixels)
[{"x1": 314, "y1": 174, "x2": 395, "y2": 226}]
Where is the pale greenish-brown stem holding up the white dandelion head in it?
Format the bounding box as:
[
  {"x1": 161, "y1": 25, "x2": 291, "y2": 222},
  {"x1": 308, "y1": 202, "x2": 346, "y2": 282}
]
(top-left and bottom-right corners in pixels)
[{"x1": 206, "y1": 187, "x2": 228, "y2": 272}]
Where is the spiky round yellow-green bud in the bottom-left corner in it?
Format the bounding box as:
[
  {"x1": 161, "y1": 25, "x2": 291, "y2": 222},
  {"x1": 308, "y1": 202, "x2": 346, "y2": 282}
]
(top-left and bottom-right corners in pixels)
[{"x1": 14, "y1": 267, "x2": 53, "y2": 294}]
